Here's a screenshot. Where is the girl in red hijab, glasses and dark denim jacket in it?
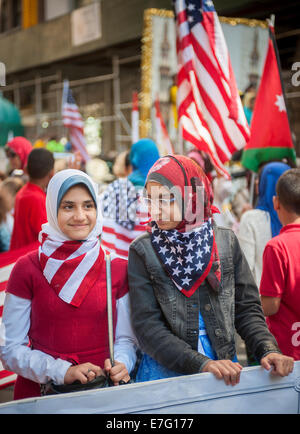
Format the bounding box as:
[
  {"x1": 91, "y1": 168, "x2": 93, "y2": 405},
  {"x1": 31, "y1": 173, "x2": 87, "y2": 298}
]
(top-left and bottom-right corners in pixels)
[{"x1": 128, "y1": 156, "x2": 293, "y2": 385}]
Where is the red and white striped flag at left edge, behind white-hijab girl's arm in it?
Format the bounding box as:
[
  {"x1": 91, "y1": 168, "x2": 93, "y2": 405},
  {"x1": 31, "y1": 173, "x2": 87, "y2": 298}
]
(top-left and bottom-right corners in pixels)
[{"x1": 0, "y1": 243, "x2": 39, "y2": 390}]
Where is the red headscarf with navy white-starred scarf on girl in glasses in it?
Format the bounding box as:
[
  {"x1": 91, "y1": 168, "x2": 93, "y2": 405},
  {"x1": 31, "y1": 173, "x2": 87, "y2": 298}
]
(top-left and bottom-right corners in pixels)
[{"x1": 148, "y1": 156, "x2": 221, "y2": 297}]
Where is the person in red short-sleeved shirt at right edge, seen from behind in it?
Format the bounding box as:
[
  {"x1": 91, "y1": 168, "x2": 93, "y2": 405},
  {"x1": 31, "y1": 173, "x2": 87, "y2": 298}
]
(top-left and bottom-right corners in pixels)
[{"x1": 260, "y1": 168, "x2": 300, "y2": 360}]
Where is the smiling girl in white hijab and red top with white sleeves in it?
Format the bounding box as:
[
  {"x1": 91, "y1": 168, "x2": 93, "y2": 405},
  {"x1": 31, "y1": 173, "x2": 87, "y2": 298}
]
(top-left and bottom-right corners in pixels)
[{"x1": 0, "y1": 170, "x2": 136, "y2": 399}]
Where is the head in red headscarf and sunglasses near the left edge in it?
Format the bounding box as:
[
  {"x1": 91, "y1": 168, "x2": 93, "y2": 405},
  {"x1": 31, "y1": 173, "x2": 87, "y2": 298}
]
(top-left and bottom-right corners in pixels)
[{"x1": 5, "y1": 137, "x2": 33, "y2": 170}]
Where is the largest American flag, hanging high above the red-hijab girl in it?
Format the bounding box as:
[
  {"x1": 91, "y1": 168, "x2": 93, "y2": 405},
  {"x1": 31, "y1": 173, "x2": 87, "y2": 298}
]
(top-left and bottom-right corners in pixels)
[{"x1": 174, "y1": 0, "x2": 250, "y2": 177}]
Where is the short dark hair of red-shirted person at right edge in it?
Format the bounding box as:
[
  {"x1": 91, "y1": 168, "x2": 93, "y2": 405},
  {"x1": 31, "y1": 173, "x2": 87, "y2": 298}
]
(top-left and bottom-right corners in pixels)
[{"x1": 276, "y1": 168, "x2": 300, "y2": 216}]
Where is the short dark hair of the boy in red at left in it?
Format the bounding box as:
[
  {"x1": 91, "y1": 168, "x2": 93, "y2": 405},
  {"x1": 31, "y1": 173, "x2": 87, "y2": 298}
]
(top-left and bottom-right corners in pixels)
[{"x1": 27, "y1": 148, "x2": 54, "y2": 179}]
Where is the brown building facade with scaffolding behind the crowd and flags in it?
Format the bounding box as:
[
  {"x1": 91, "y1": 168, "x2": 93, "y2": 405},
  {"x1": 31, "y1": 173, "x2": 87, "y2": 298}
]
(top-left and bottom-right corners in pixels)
[{"x1": 0, "y1": 0, "x2": 300, "y2": 158}]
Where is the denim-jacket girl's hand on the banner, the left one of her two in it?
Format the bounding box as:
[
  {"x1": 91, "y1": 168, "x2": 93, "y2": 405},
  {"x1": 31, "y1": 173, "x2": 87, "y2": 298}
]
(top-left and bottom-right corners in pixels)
[{"x1": 202, "y1": 360, "x2": 243, "y2": 386}]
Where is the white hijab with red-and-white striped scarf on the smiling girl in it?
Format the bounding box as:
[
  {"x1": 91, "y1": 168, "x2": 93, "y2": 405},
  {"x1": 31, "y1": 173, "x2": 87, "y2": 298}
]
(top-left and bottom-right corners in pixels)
[{"x1": 39, "y1": 169, "x2": 104, "y2": 307}]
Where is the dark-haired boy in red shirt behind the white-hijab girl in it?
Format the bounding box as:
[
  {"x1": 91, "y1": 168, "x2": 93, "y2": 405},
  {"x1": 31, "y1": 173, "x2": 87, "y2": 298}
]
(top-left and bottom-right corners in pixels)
[{"x1": 10, "y1": 148, "x2": 54, "y2": 250}]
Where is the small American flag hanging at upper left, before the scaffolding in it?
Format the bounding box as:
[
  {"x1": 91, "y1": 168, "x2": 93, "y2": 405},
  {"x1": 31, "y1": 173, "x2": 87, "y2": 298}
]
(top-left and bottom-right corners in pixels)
[{"x1": 62, "y1": 80, "x2": 90, "y2": 162}]
